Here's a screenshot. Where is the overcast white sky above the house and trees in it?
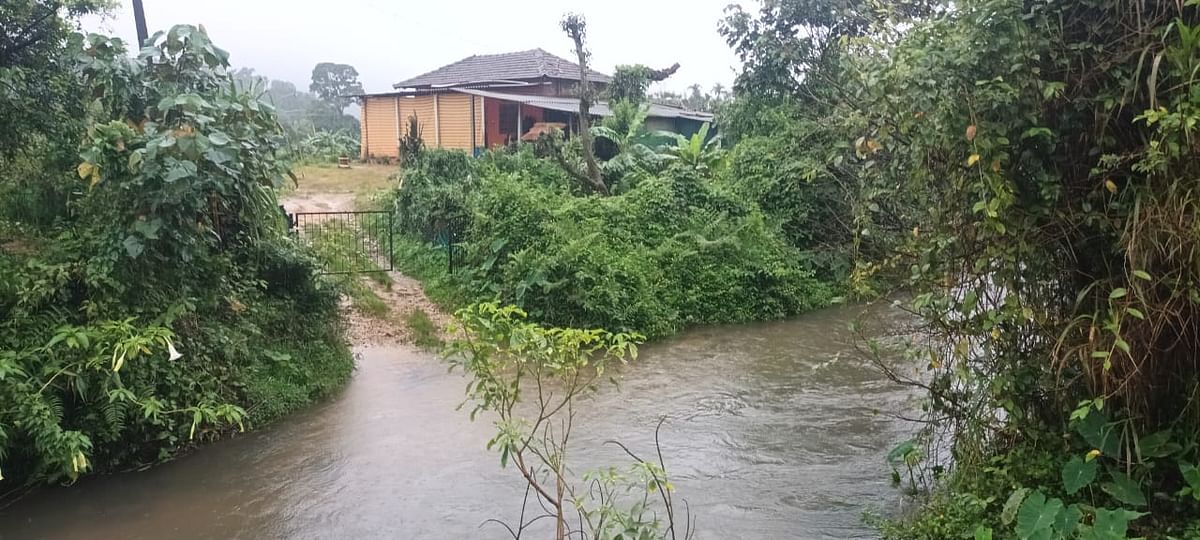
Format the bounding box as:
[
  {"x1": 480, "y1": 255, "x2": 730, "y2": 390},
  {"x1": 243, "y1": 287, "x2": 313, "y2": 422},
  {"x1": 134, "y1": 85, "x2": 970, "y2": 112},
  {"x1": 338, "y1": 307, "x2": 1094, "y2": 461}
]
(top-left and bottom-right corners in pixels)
[{"x1": 84, "y1": 0, "x2": 756, "y2": 92}]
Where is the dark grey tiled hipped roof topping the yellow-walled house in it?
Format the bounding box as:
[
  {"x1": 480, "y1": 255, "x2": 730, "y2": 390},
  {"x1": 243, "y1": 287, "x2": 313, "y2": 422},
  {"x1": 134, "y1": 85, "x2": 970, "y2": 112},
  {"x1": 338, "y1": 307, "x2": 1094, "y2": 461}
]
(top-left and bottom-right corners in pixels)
[{"x1": 392, "y1": 49, "x2": 612, "y2": 89}]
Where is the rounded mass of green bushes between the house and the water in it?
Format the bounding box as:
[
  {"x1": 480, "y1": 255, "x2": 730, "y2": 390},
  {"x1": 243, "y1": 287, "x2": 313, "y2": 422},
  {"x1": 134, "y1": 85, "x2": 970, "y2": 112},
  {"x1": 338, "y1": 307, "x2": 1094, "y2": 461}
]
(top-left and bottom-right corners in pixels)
[{"x1": 384, "y1": 144, "x2": 835, "y2": 336}]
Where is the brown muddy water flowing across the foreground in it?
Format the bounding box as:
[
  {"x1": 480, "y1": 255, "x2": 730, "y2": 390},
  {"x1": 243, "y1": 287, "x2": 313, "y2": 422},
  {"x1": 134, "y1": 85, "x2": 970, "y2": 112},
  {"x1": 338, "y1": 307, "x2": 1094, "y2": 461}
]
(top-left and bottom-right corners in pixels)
[{"x1": 0, "y1": 301, "x2": 916, "y2": 540}]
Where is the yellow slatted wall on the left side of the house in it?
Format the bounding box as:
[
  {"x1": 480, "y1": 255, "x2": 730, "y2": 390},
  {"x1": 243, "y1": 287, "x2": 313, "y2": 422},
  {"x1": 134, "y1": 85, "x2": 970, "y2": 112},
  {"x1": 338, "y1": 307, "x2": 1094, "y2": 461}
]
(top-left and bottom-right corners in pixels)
[{"x1": 361, "y1": 92, "x2": 484, "y2": 157}]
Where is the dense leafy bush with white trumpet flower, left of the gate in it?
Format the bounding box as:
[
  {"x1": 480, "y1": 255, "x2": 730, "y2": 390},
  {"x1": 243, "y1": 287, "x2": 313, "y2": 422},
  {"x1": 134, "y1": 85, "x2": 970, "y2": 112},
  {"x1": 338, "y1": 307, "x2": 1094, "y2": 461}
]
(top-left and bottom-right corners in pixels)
[{"x1": 0, "y1": 26, "x2": 353, "y2": 485}]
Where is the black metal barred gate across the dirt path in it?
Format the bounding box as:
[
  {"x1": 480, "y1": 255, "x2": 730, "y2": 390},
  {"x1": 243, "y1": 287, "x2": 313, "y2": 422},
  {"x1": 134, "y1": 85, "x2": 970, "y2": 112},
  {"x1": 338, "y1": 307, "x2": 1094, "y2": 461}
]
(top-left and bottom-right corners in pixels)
[{"x1": 288, "y1": 211, "x2": 394, "y2": 274}]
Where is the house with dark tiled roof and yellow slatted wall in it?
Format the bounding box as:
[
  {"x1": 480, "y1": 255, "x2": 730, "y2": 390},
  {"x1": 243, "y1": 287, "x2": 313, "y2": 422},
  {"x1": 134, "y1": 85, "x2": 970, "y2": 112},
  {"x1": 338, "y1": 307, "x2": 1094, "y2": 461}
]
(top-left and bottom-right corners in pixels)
[{"x1": 360, "y1": 49, "x2": 712, "y2": 160}]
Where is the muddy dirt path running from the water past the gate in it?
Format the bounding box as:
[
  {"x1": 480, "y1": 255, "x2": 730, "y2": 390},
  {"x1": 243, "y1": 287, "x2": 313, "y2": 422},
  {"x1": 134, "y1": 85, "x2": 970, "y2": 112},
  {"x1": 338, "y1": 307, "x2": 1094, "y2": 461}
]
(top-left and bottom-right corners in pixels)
[{"x1": 281, "y1": 166, "x2": 450, "y2": 346}]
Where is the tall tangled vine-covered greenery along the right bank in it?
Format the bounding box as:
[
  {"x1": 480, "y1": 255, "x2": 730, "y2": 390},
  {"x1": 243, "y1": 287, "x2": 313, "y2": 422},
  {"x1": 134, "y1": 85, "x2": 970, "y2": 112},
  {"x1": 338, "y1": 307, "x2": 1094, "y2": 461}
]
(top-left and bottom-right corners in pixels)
[{"x1": 725, "y1": 0, "x2": 1200, "y2": 540}]
